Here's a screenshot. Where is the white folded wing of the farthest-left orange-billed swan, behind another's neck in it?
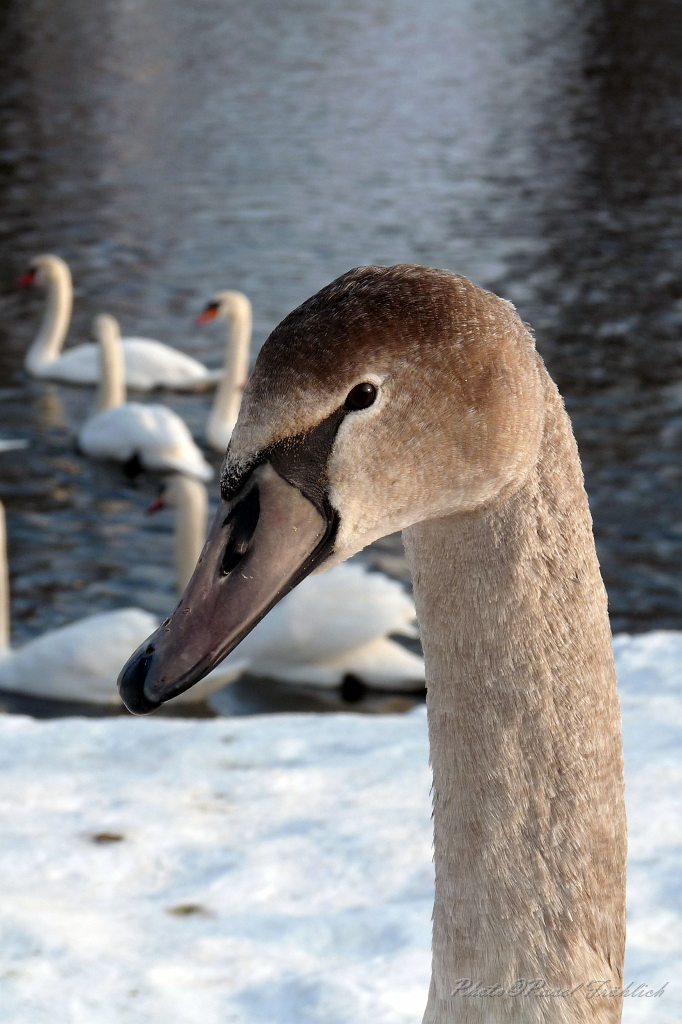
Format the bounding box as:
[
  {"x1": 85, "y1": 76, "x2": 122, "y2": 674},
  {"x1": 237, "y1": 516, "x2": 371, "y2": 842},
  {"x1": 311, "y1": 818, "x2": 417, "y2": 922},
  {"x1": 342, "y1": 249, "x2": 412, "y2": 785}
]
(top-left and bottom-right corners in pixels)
[{"x1": 121, "y1": 338, "x2": 214, "y2": 391}]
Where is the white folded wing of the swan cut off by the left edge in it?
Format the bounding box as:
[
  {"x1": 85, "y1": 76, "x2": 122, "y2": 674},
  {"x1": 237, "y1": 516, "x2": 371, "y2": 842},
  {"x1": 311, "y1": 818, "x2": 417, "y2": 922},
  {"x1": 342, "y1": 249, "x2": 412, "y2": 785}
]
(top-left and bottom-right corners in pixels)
[{"x1": 0, "y1": 608, "x2": 158, "y2": 705}]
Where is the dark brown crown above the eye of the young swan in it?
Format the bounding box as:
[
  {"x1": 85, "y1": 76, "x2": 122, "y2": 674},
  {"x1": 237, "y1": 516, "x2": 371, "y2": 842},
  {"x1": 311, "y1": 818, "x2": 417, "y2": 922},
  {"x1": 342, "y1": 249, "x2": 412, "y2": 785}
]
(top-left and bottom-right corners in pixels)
[{"x1": 228, "y1": 265, "x2": 532, "y2": 465}]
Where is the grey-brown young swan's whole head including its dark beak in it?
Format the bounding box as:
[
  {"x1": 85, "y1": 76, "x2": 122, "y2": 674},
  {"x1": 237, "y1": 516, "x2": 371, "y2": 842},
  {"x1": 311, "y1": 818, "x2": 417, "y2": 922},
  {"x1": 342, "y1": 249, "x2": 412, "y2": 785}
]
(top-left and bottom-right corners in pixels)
[{"x1": 120, "y1": 266, "x2": 544, "y2": 713}]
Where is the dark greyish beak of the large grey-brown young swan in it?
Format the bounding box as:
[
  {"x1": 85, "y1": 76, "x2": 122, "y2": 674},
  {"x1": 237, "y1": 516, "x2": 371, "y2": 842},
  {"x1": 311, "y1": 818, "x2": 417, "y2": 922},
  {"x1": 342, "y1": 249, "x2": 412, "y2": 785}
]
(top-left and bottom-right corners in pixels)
[{"x1": 119, "y1": 462, "x2": 337, "y2": 715}]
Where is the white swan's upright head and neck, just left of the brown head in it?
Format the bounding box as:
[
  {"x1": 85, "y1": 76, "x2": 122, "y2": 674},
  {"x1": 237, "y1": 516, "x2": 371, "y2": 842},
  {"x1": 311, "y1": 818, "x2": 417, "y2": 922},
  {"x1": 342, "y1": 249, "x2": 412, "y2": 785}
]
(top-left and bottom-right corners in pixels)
[{"x1": 196, "y1": 292, "x2": 253, "y2": 455}]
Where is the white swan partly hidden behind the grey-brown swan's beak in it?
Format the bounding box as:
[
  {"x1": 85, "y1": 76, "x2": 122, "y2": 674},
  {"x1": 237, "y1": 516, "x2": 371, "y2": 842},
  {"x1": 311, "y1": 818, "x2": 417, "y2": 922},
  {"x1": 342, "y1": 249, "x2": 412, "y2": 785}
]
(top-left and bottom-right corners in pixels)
[{"x1": 150, "y1": 474, "x2": 424, "y2": 691}]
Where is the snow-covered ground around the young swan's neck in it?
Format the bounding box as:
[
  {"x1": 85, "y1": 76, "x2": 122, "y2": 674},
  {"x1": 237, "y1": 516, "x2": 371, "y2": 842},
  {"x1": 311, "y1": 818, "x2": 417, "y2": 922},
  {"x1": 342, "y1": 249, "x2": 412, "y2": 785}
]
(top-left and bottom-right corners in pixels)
[{"x1": 0, "y1": 634, "x2": 682, "y2": 1024}]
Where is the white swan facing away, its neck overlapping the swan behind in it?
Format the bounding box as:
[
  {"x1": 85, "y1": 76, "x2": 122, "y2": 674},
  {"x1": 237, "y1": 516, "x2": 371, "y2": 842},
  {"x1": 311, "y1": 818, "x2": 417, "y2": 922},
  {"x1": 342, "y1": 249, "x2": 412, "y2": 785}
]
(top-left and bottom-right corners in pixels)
[{"x1": 78, "y1": 313, "x2": 213, "y2": 480}]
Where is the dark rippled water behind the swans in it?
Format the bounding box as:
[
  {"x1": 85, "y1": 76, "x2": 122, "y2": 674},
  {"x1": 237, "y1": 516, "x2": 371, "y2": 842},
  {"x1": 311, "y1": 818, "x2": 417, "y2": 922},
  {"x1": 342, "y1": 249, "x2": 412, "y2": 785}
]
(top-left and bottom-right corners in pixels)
[{"x1": 0, "y1": 0, "x2": 682, "y2": 716}]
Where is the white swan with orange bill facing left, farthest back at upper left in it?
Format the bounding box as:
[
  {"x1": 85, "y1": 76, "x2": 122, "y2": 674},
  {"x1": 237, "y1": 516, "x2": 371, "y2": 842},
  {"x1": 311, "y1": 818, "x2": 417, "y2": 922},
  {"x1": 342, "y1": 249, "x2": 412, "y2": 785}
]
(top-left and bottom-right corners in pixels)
[{"x1": 18, "y1": 254, "x2": 221, "y2": 391}]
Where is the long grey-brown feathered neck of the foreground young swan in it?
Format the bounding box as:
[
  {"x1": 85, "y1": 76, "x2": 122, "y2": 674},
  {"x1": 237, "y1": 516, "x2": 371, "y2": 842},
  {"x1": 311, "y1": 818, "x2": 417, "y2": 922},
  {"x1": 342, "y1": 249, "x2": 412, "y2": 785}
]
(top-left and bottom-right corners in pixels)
[{"x1": 403, "y1": 377, "x2": 626, "y2": 1024}]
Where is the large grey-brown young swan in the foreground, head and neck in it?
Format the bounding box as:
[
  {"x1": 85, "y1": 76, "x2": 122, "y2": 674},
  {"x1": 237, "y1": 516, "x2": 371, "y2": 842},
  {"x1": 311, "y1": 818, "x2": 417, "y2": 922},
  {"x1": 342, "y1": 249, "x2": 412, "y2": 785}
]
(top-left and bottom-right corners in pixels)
[{"x1": 120, "y1": 266, "x2": 626, "y2": 1024}]
